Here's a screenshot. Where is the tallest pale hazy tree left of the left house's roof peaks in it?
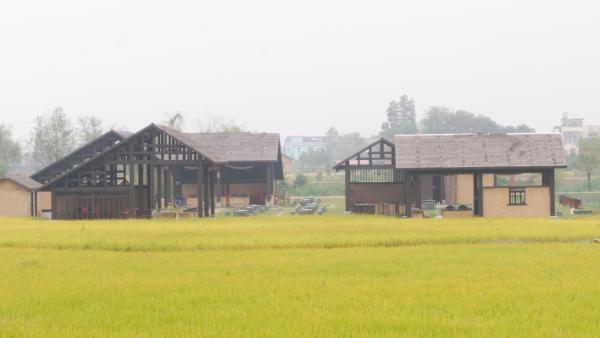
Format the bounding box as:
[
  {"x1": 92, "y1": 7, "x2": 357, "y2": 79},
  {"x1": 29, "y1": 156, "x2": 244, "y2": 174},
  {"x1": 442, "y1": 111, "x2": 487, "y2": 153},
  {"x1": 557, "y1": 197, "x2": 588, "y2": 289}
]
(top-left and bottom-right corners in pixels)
[{"x1": 31, "y1": 107, "x2": 75, "y2": 168}]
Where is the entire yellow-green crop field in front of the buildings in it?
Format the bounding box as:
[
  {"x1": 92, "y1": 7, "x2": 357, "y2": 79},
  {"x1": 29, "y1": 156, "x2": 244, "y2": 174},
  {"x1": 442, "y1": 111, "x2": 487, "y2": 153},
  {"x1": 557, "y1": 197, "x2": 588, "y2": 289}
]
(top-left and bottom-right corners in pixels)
[{"x1": 0, "y1": 216, "x2": 600, "y2": 337}]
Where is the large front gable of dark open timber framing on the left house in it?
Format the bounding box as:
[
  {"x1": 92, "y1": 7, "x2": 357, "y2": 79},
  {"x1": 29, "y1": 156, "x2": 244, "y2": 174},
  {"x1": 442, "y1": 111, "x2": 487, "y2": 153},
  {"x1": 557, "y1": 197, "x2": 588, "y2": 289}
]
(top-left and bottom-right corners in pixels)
[{"x1": 47, "y1": 125, "x2": 216, "y2": 218}]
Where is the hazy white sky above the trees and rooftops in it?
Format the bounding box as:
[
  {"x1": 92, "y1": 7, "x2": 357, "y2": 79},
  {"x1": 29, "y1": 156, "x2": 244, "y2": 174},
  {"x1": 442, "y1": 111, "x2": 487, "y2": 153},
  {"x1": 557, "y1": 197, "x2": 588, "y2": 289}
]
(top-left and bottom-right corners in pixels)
[{"x1": 0, "y1": 0, "x2": 600, "y2": 138}]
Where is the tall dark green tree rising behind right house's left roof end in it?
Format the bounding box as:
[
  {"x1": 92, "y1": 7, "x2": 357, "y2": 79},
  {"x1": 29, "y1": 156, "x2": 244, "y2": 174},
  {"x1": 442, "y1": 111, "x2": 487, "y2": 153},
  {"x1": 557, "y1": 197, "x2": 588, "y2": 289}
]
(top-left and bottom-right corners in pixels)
[{"x1": 380, "y1": 95, "x2": 417, "y2": 140}]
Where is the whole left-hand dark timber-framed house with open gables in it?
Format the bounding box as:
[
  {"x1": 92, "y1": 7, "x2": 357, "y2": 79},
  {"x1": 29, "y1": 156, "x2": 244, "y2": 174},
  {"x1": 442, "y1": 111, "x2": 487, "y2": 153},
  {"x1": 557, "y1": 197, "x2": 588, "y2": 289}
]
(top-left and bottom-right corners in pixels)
[{"x1": 32, "y1": 124, "x2": 283, "y2": 219}]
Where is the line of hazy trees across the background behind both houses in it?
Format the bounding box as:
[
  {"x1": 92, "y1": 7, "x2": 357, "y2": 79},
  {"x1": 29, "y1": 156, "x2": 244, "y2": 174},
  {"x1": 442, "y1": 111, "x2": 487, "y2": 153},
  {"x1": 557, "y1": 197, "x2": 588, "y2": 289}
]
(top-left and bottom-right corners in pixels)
[{"x1": 0, "y1": 100, "x2": 600, "y2": 190}]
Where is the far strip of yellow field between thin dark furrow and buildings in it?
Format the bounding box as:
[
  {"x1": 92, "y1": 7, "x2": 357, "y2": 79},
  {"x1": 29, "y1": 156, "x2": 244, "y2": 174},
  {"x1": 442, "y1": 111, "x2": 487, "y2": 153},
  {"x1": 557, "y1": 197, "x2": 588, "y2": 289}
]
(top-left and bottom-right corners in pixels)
[{"x1": 0, "y1": 215, "x2": 600, "y2": 251}]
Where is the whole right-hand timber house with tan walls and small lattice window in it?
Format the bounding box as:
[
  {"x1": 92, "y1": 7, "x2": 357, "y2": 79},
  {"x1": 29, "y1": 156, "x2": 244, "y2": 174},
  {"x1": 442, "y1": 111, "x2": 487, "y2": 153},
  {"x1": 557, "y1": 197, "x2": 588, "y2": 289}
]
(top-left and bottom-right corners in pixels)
[{"x1": 334, "y1": 133, "x2": 566, "y2": 217}]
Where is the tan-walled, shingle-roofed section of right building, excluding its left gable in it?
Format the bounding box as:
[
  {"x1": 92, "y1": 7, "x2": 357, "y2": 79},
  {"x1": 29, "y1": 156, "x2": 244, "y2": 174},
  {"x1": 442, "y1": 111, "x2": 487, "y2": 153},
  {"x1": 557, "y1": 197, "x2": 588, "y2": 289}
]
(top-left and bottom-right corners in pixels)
[{"x1": 395, "y1": 133, "x2": 566, "y2": 217}]
